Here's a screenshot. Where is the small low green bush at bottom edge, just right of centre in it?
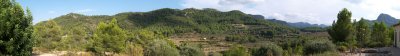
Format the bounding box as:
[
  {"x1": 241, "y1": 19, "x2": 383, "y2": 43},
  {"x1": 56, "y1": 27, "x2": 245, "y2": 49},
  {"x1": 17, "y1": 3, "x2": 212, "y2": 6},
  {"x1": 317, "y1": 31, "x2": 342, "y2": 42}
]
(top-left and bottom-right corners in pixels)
[{"x1": 224, "y1": 45, "x2": 250, "y2": 56}]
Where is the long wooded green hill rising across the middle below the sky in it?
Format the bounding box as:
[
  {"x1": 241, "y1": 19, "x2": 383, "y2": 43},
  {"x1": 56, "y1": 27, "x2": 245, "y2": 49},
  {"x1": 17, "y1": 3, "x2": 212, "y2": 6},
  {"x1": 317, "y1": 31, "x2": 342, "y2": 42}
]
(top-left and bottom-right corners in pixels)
[{"x1": 35, "y1": 8, "x2": 299, "y2": 38}]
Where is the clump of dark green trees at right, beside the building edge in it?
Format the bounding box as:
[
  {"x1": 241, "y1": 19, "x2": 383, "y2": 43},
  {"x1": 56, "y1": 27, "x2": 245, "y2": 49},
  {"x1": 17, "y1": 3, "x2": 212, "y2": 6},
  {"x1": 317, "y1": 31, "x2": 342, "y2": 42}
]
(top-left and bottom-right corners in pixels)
[{"x1": 328, "y1": 8, "x2": 394, "y2": 51}]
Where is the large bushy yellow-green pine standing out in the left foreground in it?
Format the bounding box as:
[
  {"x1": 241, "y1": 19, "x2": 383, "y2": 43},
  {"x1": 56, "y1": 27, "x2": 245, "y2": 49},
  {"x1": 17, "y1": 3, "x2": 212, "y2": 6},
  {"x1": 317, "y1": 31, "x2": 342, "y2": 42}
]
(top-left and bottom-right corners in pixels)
[{"x1": 90, "y1": 18, "x2": 127, "y2": 54}]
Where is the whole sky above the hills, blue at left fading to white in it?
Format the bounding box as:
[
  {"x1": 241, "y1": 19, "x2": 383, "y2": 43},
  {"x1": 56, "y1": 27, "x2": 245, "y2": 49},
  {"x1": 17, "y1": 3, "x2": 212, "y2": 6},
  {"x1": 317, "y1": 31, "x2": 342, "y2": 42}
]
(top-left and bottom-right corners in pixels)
[{"x1": 17, "y1": 0, "x2": 400, "y2": 25}]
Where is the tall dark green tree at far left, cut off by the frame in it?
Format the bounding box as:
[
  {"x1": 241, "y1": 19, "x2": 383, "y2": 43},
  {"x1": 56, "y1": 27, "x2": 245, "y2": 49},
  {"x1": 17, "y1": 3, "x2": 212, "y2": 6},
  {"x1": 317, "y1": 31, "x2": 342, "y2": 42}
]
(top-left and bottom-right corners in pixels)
[{"x1": 0, "y1": 0, "x2": 33, "y2": 56}]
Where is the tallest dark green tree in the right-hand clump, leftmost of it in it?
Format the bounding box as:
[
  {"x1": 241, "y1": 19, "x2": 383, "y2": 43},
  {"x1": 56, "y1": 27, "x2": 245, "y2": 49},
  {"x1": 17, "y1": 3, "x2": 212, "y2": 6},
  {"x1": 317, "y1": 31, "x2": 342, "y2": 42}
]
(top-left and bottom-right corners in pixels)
[{"x1": 328, "y1": 8, "x2": 353, "y2": 43}]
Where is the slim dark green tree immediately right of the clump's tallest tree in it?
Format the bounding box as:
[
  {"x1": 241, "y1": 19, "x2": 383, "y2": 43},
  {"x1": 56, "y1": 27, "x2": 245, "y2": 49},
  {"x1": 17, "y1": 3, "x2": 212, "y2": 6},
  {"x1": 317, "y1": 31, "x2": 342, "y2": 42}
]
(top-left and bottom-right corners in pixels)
[{"x1": 356, "y1": 18, "x2": 371, "y2": 47}]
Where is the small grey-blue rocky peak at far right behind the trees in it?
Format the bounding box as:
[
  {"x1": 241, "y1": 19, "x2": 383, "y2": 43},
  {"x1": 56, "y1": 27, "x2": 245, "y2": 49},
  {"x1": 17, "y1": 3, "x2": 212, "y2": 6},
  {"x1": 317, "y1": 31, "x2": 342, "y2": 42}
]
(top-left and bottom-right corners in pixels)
[{"x1": 374, "y1": 13, "x2": 399, "y2": 26}]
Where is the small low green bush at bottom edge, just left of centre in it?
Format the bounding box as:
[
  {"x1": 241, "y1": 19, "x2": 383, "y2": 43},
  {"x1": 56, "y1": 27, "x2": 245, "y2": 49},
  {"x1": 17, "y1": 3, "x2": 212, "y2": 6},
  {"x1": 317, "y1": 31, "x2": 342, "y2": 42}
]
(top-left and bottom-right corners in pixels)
[{"x1": 179, "y1": 45, "x2": 205, "y2": 56}]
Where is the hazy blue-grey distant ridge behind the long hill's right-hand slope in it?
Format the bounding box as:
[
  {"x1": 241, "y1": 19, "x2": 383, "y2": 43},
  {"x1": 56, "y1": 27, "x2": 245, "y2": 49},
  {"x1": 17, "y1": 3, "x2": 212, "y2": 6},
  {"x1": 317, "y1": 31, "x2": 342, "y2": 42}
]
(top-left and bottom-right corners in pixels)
[{"x1": 252, "y1": 15, "x2": 327, "y2": 28}]
